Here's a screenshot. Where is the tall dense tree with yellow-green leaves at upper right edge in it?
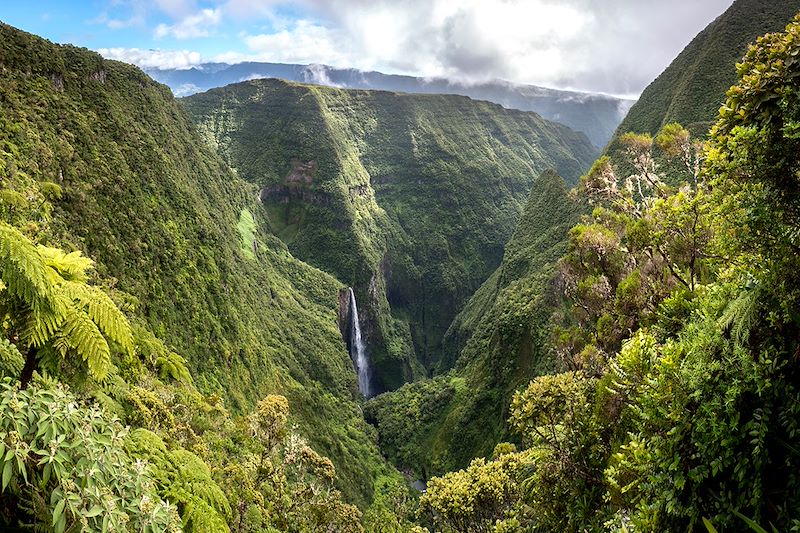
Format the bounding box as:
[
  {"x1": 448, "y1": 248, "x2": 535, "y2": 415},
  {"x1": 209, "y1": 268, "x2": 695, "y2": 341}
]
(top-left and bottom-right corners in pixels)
[{"x1": 707, "y1": 16, "x2": 800, "y2": 310}]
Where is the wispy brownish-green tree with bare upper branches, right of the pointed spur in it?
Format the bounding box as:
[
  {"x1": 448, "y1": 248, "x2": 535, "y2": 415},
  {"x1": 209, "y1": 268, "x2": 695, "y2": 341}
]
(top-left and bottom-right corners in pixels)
[{"x1": 556, "y1": 124, "x2": 721, "y2": 366}]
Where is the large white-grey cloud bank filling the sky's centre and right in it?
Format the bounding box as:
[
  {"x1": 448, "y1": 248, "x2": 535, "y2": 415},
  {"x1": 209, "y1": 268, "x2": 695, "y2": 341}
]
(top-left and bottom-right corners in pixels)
[{"x1": 290, "y1": 0, "x2": 731, "y2": 94}]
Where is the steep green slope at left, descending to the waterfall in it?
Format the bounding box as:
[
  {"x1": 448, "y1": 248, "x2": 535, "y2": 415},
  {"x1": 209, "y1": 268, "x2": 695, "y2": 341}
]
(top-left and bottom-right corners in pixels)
[{"x1": 0, "y1": 21, "x2": 390, "y2": 503}]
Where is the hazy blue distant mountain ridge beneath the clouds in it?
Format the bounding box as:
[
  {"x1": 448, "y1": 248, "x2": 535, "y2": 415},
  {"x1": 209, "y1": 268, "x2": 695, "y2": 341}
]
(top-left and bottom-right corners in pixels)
[{"x1": 144, "y1": 62, "x2": 633, "y2": 148}]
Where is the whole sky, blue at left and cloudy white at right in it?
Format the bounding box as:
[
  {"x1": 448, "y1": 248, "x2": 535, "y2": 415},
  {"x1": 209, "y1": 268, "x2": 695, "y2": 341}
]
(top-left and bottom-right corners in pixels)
[{"x1": 0, "y1": 0, "x2": 732, "y2": 97}]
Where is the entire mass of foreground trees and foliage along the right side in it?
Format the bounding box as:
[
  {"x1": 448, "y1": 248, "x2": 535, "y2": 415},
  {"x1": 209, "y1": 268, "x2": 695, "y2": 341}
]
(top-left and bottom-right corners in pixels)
[{"x1": 424, "y1": 15, "x2": 800, "y2": 531}]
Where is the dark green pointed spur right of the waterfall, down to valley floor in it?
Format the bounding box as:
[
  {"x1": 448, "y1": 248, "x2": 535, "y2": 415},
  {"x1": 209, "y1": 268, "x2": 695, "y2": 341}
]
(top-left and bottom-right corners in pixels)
[{"x1": 365, "y1": 172, "x2": 582, "y2": 475}]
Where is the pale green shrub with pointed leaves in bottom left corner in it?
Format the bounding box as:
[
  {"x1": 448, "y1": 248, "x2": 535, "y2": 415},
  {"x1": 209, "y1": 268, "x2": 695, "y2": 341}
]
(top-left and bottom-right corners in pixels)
[{"x1": 0, "y1": 379, "x2": 180, "y2": 533}]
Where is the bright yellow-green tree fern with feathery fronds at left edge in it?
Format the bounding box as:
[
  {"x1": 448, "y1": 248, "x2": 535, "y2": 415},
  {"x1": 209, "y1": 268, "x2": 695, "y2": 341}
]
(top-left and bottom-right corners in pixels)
[{"x1": 0, "y1": 222, "x2": 134, "y2": 389}]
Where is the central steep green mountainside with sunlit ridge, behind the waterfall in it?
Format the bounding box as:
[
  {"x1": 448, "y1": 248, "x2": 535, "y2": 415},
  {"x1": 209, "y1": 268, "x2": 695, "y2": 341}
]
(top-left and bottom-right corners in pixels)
[{"x1": 183, "y1": 80, "x2": 596, "y2": 390}]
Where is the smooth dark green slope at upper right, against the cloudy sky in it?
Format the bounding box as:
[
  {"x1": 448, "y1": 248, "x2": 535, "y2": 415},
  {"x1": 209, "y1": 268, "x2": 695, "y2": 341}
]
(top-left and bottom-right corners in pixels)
[{"x1": 612, "y1": 0, "x2": 800, "y2": 138}]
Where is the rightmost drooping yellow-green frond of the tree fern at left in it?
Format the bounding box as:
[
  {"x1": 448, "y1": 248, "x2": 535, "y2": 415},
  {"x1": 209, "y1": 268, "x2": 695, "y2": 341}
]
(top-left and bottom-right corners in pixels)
[{"x1": 60, "y1": 281, "x2": 133, "y2": 356}]
